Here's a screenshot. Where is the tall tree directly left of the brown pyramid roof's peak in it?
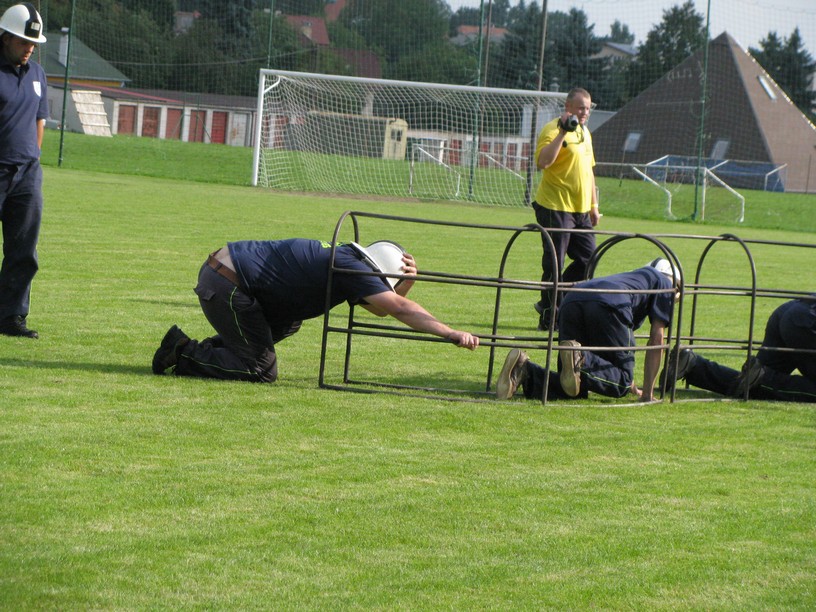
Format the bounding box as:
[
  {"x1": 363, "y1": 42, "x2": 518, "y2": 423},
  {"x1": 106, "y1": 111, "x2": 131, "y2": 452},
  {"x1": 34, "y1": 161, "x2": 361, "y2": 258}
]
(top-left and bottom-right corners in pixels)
[{"x1": 628, "y1": 0, "x2": 707, "y2": 97}]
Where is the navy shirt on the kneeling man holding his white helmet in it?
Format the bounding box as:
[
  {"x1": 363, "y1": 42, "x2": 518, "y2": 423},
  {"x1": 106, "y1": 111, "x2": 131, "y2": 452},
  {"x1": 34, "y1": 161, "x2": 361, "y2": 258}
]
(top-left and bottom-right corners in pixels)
[{"x1": 227, "y1": 238, "x2": 391, "y2": 325}]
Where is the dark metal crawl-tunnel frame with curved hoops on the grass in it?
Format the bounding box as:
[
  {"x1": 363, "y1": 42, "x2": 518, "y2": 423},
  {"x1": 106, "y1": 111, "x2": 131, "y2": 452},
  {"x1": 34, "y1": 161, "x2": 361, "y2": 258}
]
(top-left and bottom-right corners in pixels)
[{"x1": 319, "y1": 211, "x2": 816, "y2": 405}]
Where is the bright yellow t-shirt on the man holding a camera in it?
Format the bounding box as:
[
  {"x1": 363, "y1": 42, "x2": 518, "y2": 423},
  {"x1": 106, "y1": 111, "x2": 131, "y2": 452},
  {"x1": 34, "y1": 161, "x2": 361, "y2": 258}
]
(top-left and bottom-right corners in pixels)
[{"x1": 535, "y1": 118, "x2": 595, "y2": 213}]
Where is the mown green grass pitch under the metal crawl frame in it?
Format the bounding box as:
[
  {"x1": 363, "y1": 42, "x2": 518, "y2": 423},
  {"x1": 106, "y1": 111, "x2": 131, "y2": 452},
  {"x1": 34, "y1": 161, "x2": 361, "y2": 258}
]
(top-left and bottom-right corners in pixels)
[{"x1": 0, "y1": 134, "x2": 816, "y2": 610}]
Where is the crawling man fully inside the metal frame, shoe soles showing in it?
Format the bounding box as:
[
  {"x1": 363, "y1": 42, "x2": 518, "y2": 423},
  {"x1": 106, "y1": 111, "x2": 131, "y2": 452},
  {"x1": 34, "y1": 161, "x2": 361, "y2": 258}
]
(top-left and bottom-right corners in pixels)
[{"x1": 496, "y1": 258, "x2": 680, "y2": 402}]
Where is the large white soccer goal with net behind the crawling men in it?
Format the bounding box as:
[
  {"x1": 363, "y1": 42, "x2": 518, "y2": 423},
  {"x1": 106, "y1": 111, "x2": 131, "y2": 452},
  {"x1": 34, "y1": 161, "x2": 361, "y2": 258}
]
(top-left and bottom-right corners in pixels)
[{"x1": 252, "y1": 70, "x2": 566, "y2": 206}]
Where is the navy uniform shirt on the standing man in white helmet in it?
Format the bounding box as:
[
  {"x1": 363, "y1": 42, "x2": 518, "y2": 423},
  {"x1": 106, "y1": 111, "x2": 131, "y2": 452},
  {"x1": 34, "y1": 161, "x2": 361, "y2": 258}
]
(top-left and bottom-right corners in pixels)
[{"x1": 0, "y1": 53, "x2": 48, "y2": 165}]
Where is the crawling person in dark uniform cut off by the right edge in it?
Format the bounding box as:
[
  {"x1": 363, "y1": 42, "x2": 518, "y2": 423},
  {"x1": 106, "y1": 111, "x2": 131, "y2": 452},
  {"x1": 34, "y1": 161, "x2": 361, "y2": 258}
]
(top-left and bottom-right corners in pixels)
[{"x1": 667, "y1": 294, "x2": 816, "y2": 403}]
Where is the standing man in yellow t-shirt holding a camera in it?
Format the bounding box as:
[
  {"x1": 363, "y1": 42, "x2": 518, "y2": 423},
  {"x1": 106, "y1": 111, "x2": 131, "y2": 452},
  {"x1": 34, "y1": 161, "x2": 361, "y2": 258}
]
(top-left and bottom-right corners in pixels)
[{"x1": 533, "y1": 87, "x2": 601, "y2": 331}]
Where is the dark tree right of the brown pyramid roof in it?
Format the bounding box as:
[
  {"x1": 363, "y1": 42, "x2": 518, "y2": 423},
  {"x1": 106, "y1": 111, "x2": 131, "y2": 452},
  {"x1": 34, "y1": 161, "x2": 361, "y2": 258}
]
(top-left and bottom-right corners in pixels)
[{"x1": 749, "y1": 28, "x2": 816, "y2": 121}]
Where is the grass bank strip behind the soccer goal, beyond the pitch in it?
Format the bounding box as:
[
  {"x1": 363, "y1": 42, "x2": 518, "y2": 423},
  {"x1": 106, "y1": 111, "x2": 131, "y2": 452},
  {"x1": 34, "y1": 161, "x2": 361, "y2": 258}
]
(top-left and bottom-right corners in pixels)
[{"x1": 43, "y1": 130, "x2": 816, "y2": 233}]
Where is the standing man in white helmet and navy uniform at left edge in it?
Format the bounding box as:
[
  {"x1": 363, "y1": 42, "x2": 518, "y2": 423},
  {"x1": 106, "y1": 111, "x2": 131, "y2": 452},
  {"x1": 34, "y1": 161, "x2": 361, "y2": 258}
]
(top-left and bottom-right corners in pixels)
[{"x1": 0, "y1": 2, "x2": 48, "y2": 338}]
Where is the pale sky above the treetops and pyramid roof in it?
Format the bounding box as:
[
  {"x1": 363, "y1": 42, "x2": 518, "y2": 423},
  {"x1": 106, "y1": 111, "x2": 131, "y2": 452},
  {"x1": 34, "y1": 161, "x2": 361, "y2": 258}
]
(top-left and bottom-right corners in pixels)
[{"x1": 447, "y1": 0, "x2": 816, "y2": 58}]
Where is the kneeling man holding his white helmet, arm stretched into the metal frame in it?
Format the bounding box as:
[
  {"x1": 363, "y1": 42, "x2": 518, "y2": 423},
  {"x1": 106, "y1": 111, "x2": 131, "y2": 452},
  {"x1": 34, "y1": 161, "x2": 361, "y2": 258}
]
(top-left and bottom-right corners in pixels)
[{"x1": 153, "y1": 238, "x2": 479, "y2": 382}]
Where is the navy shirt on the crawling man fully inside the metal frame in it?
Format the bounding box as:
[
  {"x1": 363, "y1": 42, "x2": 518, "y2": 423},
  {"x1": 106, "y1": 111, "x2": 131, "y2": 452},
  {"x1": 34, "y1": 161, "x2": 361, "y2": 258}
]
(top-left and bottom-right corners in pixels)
[{"x1": 562, "y1": 266, "x2": 674, "y2": 329}]
